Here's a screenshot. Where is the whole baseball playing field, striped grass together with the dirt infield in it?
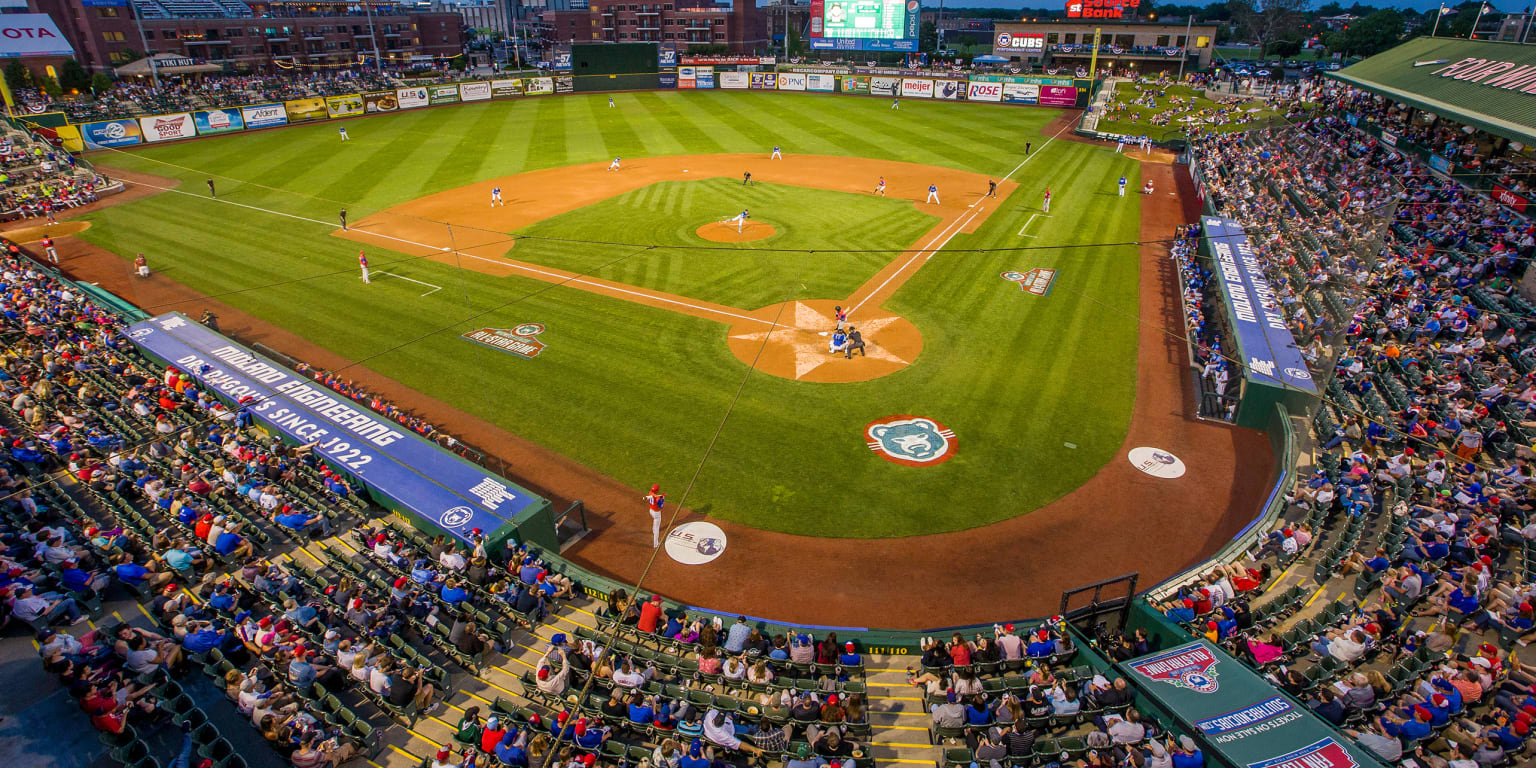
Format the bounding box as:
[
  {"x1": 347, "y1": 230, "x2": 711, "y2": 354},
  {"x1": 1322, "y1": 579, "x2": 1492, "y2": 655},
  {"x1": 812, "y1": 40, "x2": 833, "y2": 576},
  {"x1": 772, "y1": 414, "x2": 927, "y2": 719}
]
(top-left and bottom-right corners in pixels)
[{"x1": 78, "y1": 92, "x2": 1143, "y2": 538}]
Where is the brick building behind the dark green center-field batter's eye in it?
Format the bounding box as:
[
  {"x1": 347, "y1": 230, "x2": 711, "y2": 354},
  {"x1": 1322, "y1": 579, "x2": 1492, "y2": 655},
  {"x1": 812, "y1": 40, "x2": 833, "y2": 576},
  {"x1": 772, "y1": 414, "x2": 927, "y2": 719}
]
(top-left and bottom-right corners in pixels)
[{"x1": 541, "y1": 0, "x2": 768, "y2": 54}]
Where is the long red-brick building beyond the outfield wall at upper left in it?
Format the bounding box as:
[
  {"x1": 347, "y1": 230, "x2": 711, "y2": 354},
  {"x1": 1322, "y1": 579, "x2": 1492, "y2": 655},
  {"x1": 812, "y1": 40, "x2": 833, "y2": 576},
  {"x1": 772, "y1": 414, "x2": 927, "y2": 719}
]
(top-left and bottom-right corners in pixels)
[{"x1": 29, "y1": 0, "x2": 464, "y2": 72}]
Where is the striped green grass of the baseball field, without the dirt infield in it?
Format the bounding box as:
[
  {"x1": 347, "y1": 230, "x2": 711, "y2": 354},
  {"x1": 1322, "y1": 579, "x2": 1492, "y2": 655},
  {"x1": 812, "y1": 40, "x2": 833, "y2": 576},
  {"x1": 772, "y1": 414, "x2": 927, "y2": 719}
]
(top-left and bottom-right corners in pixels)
[{"x1": 83, "y1": 92, "x2": 1140, "y2": 538}]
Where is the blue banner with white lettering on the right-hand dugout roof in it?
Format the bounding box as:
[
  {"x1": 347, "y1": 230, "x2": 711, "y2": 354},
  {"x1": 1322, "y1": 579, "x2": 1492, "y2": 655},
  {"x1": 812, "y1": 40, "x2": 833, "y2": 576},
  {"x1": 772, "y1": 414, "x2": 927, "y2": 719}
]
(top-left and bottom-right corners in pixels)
[{"x1": 1201, "y1": 217, "x2": 1318, "y2": 395}]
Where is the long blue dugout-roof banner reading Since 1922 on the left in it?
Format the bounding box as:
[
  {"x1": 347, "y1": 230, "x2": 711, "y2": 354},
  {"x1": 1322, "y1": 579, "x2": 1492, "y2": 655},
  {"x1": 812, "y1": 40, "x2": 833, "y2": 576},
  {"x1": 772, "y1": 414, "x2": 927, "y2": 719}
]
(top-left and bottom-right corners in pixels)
[{"x1": 124, "y1": 312, "x2": 544, "y2": 541}]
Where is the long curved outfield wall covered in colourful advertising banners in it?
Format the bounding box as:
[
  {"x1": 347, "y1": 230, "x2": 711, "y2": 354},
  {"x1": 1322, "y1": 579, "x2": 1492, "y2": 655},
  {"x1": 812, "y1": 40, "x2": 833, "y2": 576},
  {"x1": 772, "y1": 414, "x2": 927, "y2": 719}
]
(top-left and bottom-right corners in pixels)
[{"x1": 57, "y1": 65, "x2": 1094, "y2": 152}]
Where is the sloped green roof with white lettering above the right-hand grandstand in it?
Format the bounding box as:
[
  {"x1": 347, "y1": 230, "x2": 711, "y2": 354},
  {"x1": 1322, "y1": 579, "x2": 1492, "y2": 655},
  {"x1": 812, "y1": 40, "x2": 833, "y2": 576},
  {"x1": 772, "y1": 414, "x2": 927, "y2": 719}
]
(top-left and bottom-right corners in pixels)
[{"x1": 1330, "y1": 37, "x2": 1536, "y2": 146}]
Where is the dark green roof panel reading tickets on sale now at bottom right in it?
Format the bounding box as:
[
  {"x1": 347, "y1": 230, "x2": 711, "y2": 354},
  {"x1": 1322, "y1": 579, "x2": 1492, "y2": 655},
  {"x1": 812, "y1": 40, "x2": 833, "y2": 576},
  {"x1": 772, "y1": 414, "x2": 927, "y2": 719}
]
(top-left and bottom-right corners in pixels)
[{"x1": 1120, "y1": 641, "x2": 1378, "y2": 768}]
